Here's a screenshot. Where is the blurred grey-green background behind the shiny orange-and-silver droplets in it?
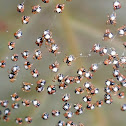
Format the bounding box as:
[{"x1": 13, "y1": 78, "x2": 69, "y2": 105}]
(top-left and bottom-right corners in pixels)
[{"x1": 0, "y1": 0, "x2": 126, "y2": 126}]
